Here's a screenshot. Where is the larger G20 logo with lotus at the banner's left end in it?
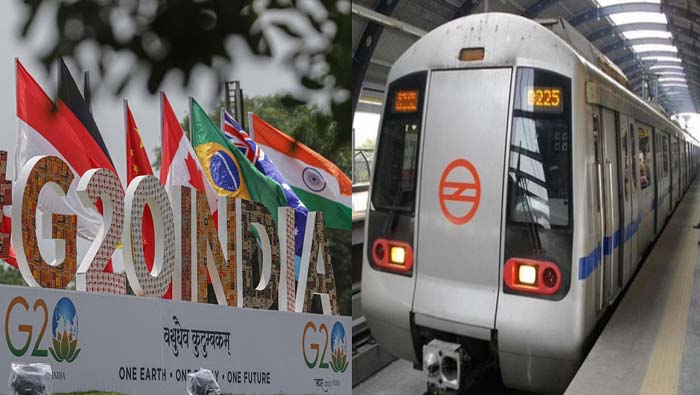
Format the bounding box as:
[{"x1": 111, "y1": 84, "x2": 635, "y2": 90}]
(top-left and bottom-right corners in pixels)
[{"x1": 5, "y1": 296, "x2": 80, "y2": 362}]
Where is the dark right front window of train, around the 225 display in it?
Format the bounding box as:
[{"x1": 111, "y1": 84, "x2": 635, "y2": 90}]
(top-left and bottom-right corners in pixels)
[{"x1": 508, "y1": 68, "x2": 571, "y2": 229}]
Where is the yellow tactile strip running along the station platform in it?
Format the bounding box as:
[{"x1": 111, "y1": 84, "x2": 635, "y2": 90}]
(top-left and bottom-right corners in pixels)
[{"x1": 639, "y1": 193, "x2": 698, "y2": 394}]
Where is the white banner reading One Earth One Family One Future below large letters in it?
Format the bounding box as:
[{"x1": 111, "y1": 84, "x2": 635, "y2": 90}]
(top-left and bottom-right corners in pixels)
[{"x1": 0, "y1": 285, "x2": 352, "y2": 395}]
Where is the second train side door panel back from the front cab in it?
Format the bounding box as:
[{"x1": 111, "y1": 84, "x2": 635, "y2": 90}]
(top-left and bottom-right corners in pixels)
[{"x1": 618, "y1": 114, "x2": 633, "y2": 283}]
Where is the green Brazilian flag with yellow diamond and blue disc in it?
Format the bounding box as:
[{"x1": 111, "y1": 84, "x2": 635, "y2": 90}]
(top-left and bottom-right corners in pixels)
[{"x1": 190, "y1": 99, "x2": 287, "y2": 222}]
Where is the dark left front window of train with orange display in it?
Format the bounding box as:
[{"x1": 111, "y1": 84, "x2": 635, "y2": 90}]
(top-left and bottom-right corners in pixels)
[{"x1": 372, "y1": 72, "x2": 427, "y2": 213}]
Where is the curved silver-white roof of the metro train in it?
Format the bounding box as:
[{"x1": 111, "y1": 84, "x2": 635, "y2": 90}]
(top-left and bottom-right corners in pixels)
[{"x1": 388, "y1": 13, "x2": 699, "y2": 145}]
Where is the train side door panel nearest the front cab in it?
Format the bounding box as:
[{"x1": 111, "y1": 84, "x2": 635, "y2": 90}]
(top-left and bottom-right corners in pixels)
[{"x1": 599, "y1": 108, "x2": 622, "y2": 303}]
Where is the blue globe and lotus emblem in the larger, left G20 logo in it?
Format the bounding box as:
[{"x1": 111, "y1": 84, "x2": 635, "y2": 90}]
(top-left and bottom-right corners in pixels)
[{"x1": 49, "y1": 297, "x2": 80, "y2": 362}]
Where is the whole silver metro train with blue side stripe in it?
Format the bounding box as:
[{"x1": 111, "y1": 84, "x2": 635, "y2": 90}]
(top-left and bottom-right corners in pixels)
[{"x1": 361, "y1": 13, "x2": 699, "y2": 393}]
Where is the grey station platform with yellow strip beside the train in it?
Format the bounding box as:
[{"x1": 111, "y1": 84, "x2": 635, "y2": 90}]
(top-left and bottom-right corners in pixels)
[{"x1": 566, "y1": 180, "x2": 700, "y2": 395}]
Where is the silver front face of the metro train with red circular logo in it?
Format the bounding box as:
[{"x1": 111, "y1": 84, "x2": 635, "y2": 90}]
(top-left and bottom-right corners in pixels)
[{"x1": 362, "y1": 14, "x2": 584, "y2": 392}]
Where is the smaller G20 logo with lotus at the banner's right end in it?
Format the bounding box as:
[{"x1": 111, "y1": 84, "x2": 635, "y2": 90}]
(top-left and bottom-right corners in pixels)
[{"x1": 301, "y1": 321, "x2": 350, "y2": 373}]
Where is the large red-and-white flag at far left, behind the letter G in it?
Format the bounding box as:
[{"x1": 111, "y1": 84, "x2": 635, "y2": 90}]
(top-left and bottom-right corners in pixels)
[{"x1": 15, "y1": 60, "x2": 117, "y2": 244}]
